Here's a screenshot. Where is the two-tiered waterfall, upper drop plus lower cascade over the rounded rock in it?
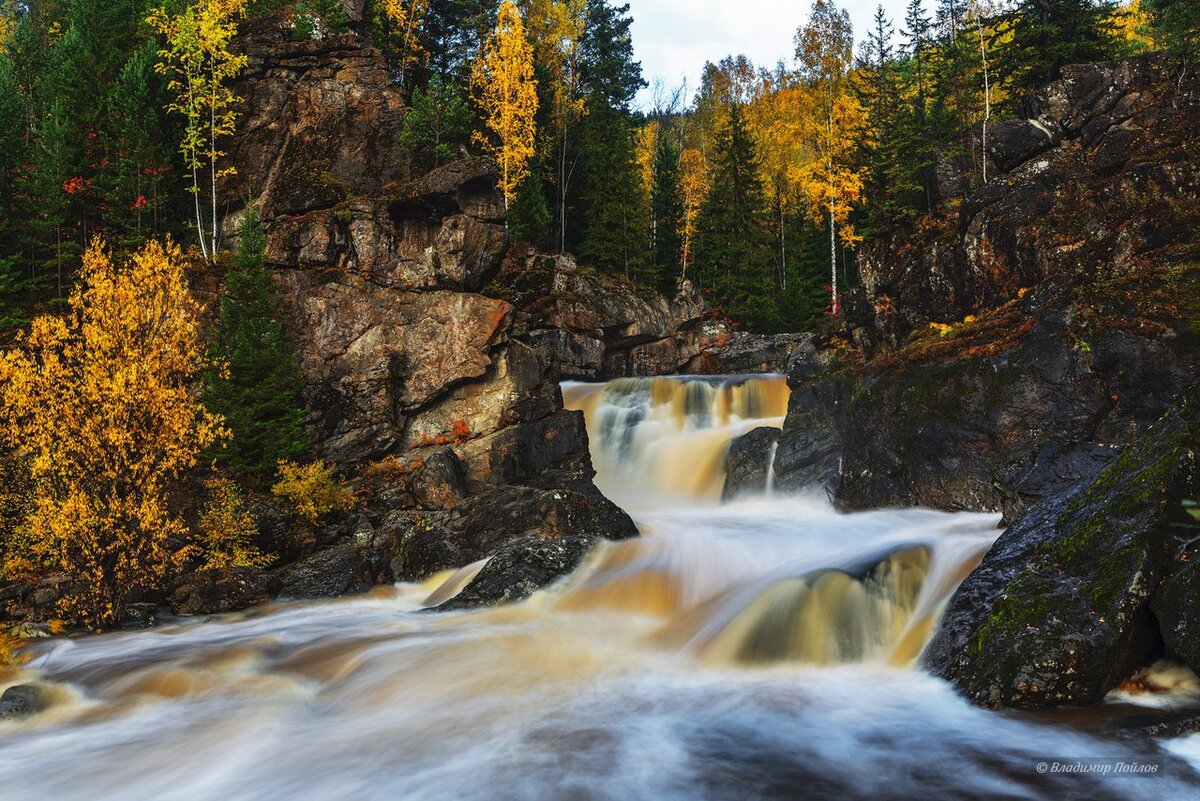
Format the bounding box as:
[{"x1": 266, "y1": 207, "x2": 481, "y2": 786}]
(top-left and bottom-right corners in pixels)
[{"x1": 560, "y1": 375, "x2": 998, "y2": 666}]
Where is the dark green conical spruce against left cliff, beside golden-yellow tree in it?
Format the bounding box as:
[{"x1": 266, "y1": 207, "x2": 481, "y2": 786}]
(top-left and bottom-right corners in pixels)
[{"x1": 204, "y1": 210, "x2": 308, "y2": 482}]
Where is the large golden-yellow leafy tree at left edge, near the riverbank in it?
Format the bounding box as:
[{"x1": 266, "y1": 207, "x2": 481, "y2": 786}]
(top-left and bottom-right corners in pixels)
[{"x1": 0, "y1": 239, "x2": 226, "y2": 628}]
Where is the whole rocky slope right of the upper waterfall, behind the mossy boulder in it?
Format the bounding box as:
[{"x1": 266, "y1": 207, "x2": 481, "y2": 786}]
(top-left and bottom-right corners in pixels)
[{"x1": 748, "y1": 56, "x2": 1200, "y2": 520}]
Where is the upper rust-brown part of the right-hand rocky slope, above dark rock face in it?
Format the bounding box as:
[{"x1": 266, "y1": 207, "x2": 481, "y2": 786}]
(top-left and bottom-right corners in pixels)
[{"x1": 858, "y1": 56, "x2": 1200, "y2": 345}]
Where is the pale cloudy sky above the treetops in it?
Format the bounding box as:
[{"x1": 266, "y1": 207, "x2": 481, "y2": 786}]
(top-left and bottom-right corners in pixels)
[{"x1": 626, "y1": 0, "x2": 907, "y2": 108}]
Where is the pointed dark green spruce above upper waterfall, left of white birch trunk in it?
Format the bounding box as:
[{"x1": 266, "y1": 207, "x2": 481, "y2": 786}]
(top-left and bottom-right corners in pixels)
[{"x1": 695, "y1": 103, "x2": 776, "y2": 330}]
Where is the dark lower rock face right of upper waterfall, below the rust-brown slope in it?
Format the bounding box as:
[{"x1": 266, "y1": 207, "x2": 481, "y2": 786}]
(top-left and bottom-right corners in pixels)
[{"x1": 758, "y1": 287, "x2": 1200, "y2": 520}]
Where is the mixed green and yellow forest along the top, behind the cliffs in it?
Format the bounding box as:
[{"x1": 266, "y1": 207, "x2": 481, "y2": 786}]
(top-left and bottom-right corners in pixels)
[{"x1": 0, "y1": 0, "x2": 1200, "y2": 331}]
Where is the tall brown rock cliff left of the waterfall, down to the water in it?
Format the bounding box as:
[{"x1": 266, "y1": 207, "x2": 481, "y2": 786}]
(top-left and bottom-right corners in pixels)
[{"x1": 211, "y1": 19, "x2": 638, "y2": 612}]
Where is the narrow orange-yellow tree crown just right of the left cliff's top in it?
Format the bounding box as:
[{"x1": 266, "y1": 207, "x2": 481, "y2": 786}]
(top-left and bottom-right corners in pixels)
[{"x1": 470, "y1": 0, "x2": 538, "y2": 206}]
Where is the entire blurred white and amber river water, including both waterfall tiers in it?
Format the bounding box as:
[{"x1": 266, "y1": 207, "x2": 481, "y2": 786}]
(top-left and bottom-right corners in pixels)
[{"x1": 0, "y1": 377, "x2": 1200, "y2": 801}]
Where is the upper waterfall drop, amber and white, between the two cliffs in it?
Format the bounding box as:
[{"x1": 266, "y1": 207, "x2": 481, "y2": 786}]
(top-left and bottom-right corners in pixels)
[{"x1": 563, "y1": 375, "x2": 791, "y2": 510}]
